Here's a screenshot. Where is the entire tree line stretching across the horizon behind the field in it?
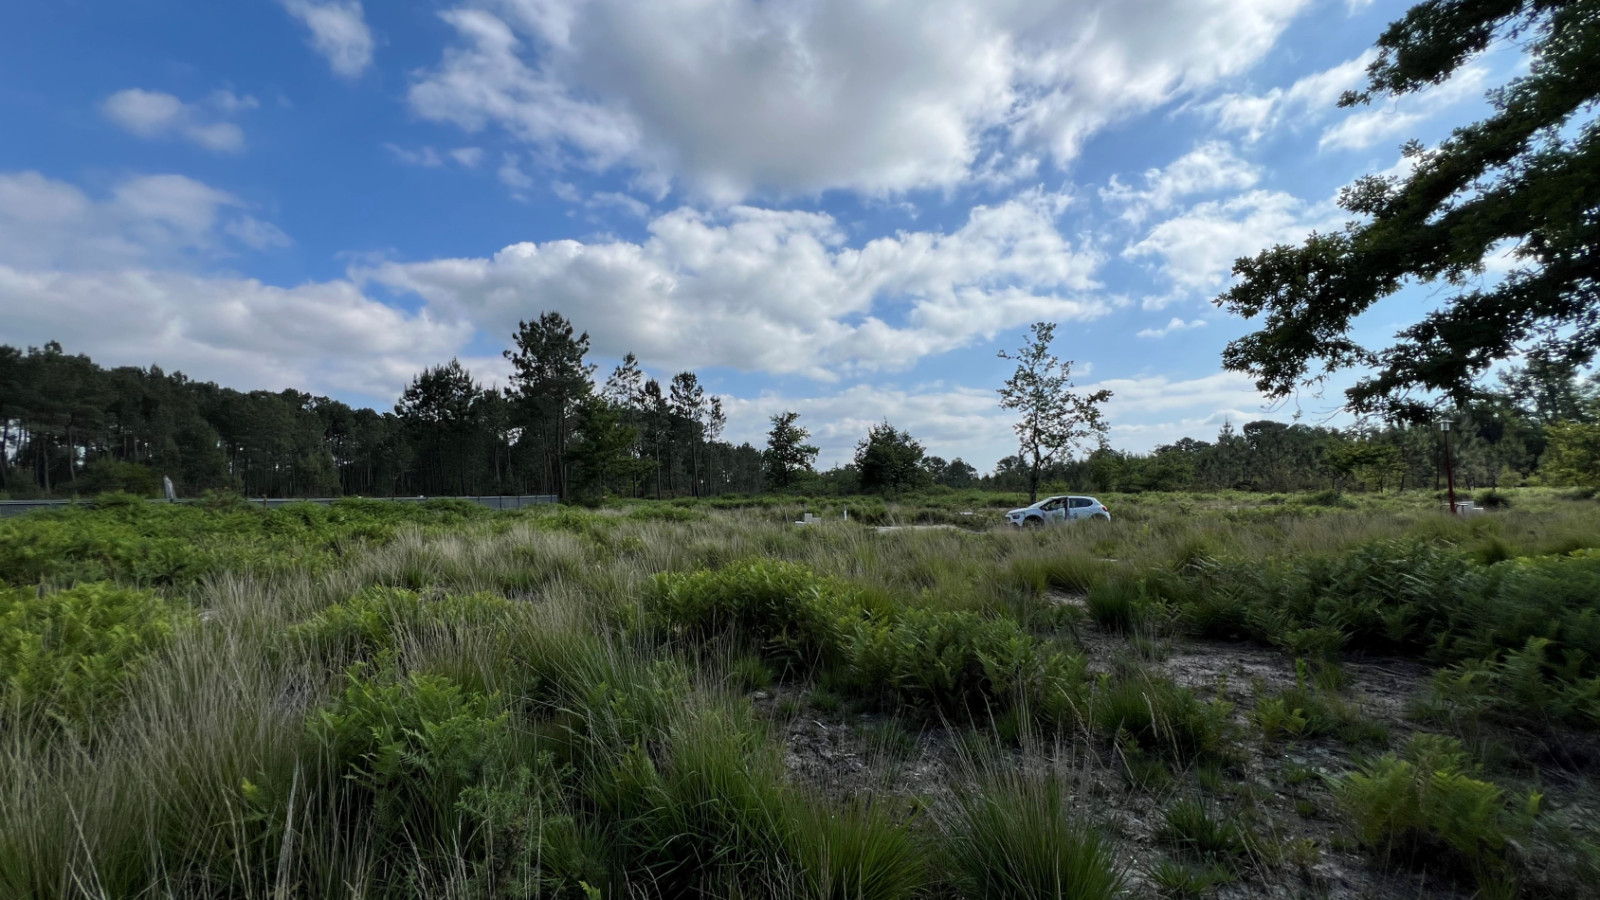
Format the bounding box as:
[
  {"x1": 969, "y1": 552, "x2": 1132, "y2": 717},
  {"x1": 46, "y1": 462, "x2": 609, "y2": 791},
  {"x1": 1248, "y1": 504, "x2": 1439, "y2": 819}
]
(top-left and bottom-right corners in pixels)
[{"x1": 0, "y1": 325, "x2": 1600, "y2": 500}]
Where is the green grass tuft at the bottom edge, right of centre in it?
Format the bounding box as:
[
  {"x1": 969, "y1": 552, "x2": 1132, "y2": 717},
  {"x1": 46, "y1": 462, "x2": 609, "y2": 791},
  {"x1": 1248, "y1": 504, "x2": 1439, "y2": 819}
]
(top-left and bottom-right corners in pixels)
[{"x1": 944, "y1": 762, "x2": 1123, "y2": 900}]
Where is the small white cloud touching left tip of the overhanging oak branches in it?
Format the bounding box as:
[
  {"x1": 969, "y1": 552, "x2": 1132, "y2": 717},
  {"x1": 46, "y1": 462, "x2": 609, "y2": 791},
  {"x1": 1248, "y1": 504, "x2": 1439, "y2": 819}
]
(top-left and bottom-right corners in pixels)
[{"x1": 1123, "y1": 191, "x2": 1342, "y2": 307}]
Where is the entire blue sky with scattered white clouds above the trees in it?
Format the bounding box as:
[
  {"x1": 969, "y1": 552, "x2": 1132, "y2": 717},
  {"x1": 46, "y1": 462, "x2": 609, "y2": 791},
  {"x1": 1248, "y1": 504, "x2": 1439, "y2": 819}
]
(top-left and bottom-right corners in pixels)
[{"x1": 0, "y1": 0, "x2": 1517, "y2": 468}]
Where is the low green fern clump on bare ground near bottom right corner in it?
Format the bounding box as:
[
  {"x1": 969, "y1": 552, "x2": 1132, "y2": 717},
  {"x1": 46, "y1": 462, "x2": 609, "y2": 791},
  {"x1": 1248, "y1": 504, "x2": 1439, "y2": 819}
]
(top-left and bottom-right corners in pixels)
[{"x1": 1331, "y1": 733, "x2": 1541, "y2": 878}]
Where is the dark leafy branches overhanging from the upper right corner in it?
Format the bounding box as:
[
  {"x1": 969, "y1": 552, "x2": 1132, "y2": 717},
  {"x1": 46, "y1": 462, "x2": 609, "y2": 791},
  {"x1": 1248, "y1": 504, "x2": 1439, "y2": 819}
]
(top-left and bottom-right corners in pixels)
[{"x1": 1218, "y1": 0, "x2": 1600, "y2": 418}]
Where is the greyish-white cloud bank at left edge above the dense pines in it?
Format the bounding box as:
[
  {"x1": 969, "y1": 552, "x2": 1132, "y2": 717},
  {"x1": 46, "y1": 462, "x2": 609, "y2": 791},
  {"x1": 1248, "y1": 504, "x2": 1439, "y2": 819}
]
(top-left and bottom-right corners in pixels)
[{"x1": 0, "y1": 171, "x2": 460, "y2": 402}]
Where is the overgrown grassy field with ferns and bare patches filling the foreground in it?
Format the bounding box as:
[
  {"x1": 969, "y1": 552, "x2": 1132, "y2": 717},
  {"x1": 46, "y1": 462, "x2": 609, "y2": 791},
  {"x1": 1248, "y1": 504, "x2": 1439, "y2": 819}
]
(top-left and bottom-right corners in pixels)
[{"x1": 0, "y1": 488, "x2": 1600, "y2": 900}]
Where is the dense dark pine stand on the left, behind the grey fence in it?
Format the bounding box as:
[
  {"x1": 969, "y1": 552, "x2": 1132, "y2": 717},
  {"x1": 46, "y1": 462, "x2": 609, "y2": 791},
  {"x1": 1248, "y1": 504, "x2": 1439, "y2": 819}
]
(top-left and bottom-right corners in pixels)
[{"x1": 0, "y1": 312, "x2": 763, "y2": 498}]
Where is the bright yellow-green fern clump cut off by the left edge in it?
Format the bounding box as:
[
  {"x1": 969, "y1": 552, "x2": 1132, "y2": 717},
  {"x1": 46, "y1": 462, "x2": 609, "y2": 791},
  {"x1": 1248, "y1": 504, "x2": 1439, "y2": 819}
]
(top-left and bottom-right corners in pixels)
[{"x1": 0, "y1": 583, "x2": 194, "y2": 721}]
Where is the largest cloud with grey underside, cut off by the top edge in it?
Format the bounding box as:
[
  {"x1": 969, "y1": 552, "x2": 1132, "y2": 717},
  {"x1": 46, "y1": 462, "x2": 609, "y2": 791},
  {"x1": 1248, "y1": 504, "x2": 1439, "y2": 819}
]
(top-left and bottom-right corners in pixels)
[{"x1": 410, "y1": 0, "x2": 1306, "y2": 200}]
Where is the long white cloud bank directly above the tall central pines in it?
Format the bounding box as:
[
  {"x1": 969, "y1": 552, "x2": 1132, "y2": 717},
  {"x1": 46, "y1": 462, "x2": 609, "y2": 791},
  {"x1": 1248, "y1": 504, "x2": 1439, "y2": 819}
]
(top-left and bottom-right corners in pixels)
[{"x1": 357, "y1": 194, "x2": 1110, "y2": 381}]
